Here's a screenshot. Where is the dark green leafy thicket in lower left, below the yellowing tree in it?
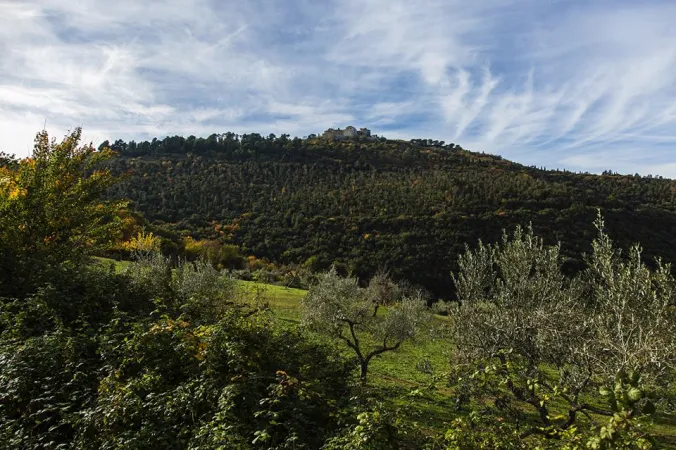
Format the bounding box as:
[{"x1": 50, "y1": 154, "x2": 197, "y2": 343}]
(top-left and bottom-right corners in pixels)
[{"x1": 0, "y1": 261, "x2": 352, "y2": 449}]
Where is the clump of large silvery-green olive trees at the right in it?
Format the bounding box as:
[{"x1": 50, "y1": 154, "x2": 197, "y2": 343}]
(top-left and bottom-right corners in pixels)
[{"x1": 452, "y1": 217, "x2": 676, "y2": 437}]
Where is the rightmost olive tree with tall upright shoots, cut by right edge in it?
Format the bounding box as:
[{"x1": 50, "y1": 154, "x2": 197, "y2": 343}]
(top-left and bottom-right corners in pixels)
[{"x1": 581, "y1": 217, "x2": 676, "y2": 382}]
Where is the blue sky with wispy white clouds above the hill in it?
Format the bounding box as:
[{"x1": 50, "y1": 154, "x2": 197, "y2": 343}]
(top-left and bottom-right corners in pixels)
[{"x1": 0, "y1": 0, "x2": 676, "y2": 178}]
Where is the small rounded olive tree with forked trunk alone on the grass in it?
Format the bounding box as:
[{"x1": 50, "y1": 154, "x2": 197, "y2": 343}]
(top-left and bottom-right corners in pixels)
[{"x1": 301, "y1": 269, "x2": 429, "y2": 383}]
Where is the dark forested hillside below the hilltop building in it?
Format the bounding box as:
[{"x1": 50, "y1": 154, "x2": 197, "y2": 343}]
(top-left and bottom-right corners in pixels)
[{"x1": 103, "y1": 133, "x2": 676, "y2": 298}]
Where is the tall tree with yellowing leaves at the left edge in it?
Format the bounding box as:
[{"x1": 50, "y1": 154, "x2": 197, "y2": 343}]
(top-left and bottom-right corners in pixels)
[{"x1": 0, "y1": 128, "x2": 123, "y2": 295}]
